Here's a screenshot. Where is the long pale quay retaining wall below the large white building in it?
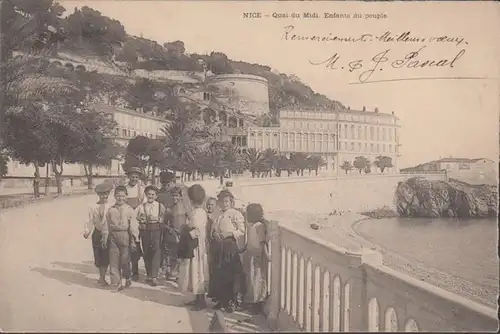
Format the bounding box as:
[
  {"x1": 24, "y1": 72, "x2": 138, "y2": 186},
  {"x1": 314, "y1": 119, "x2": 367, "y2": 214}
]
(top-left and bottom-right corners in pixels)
[{"x1": 232, "y1": 174, "x2": 446, "y2": 213}]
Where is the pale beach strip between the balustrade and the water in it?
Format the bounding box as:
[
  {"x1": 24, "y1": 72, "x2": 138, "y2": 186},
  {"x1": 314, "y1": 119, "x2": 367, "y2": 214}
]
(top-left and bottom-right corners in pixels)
[{"x1": 268, "y1": 209, "x2": 498, "y2": 308}]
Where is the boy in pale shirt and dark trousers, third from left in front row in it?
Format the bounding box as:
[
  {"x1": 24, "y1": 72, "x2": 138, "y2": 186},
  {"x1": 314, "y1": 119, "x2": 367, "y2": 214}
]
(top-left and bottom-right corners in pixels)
[{"x1": 137, "y1": 185, "x2": 165, "y2": 286}]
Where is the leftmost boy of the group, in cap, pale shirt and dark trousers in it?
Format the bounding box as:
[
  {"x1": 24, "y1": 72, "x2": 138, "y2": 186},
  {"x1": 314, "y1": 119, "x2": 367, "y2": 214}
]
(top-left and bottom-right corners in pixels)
[{"x1": 83, "y1": 183, "x2": 113, "y2": 286}]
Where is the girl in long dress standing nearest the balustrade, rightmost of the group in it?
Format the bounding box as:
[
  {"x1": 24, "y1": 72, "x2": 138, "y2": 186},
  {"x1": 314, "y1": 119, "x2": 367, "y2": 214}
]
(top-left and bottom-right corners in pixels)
[{"x1": 243, "y1": 203, "x2": 269, "y2": 313}]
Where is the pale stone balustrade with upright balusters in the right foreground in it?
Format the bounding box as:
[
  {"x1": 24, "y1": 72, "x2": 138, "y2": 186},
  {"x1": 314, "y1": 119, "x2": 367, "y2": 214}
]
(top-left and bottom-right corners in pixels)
[{"x1": 266, "y1": 222, "x2": 498, "y2": 332}]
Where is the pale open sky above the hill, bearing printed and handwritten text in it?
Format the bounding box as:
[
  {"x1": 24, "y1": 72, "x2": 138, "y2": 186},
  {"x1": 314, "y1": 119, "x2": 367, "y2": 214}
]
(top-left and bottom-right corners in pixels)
[{"x1": 61, "y1": 0, "x2": 500, "y2": 168}]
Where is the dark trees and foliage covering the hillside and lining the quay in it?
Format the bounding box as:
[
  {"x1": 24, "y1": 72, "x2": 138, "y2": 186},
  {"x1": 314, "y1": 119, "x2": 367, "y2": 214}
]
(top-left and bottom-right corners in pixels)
[{"x1": 0, "y1": 0, "x2": 391, "y2": 193}]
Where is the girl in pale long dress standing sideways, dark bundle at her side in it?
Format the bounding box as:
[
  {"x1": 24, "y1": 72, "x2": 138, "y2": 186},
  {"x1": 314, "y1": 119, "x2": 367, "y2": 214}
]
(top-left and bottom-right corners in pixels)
[{"x1": 178, "y1": 184, "x2": 209, "y2": 311}]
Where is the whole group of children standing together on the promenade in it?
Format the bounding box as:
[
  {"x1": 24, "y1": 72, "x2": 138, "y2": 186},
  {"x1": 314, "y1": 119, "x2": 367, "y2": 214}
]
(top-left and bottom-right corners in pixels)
[{"x1": 84, "y1": 171, "x2": 269, "y2": 312}]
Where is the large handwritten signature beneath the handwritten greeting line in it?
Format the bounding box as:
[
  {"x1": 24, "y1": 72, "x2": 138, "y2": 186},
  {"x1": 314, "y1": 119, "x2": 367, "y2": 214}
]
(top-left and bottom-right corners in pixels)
[{"x1": 309, "y1": 46, "x2": 465, "y2": 83}]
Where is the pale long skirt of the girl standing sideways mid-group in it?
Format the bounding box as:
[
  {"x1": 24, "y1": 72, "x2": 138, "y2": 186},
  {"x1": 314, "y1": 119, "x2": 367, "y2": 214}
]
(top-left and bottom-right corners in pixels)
[{"x1": 178, "y1": 247, "x2": 209, "y2": 295}]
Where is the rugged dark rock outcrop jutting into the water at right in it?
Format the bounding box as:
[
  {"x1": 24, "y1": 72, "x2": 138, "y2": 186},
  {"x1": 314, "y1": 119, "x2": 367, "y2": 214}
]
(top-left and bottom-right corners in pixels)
[{"x1": 395, "y1": 177, "x2": 498, "y2": 218}]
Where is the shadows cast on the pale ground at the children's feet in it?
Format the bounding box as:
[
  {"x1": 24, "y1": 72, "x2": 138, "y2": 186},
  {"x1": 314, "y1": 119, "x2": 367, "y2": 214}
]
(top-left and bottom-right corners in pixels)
[{"x1": 31, "y1": 261, "x2": 209, "y2": 333}]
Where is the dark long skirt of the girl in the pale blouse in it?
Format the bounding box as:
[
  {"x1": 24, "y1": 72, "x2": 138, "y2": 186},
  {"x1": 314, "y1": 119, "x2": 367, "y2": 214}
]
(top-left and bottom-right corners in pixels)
[{"x1": 210, "y1": 237, "x2": 243, "y2": 305}]
